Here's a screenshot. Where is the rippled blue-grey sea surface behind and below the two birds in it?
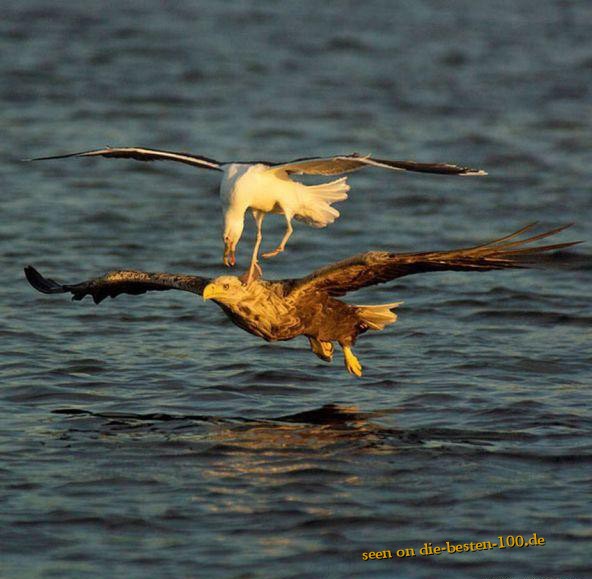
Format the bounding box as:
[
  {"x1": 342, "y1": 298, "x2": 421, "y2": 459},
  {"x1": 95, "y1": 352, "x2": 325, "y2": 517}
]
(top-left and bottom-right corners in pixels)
[{"x1": 0, "y1": 0, "x2": 592, "y2": 579}]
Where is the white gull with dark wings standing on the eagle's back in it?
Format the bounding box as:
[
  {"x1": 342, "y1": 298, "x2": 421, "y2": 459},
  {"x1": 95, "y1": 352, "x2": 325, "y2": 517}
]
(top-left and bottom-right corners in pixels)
[{"x1": 28, "y1": 147, "x2": 487, "y2": 284}]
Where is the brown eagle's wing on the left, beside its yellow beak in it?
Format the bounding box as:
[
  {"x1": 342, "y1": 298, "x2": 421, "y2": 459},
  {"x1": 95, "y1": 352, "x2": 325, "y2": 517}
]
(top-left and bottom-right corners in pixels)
[{"x1": 25, "y1": 265, "x2": 210, "y2": 304}]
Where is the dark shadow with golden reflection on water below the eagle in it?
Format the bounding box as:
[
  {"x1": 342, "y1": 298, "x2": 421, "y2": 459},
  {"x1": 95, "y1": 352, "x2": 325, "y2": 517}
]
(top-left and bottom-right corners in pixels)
[{"x1": 52, "y1": 403, "x2": 531, "y2": 453}]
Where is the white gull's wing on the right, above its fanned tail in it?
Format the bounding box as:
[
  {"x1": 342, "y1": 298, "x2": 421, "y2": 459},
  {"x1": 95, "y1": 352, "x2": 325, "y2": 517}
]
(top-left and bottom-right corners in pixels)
[{"x1": 270, "y1": 153, "x2": 487, "y2": 175}]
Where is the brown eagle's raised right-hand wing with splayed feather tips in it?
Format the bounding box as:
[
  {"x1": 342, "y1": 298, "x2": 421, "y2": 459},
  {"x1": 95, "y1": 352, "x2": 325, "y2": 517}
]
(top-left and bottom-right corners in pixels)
[{"x1": 285, "y1": 223, "x2": 581, "y2": 296}]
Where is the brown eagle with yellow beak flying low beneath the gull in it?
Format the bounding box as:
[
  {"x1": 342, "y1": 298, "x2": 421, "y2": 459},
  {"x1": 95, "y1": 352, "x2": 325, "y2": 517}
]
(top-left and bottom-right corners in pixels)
[{"x1": 25, "y1": 224, "x2": 579, "y2": 377}]
